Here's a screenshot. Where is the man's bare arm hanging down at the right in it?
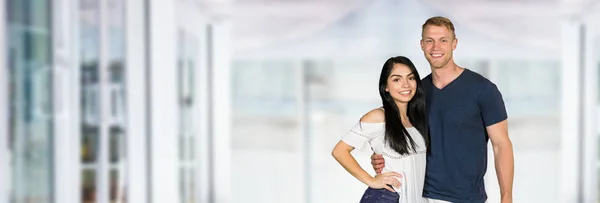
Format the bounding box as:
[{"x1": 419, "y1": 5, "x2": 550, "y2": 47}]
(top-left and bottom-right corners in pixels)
[{"x1": 486, "y1": 120, "x2": 515, "y2": 203}]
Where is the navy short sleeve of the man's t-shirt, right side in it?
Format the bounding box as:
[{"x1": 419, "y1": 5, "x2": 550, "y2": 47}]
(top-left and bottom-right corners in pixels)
[{"x1": 478, "y1": 80, "x2": 508, "y2": 127}]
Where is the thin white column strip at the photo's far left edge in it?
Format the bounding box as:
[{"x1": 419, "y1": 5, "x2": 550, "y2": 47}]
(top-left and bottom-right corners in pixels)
[{"x1": 0, "y1": 1, "x2": 11, "y2": 203}]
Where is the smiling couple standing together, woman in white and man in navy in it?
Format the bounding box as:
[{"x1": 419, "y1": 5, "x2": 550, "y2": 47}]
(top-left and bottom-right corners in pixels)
[{"x1": 332, "y1": 17, "x2": 514, "y2": 203}]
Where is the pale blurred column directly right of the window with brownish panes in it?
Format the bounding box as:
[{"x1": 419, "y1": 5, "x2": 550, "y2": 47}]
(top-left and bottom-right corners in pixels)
[{"x1": 125, "y1": 0, "x2": 150, "y2": 202}]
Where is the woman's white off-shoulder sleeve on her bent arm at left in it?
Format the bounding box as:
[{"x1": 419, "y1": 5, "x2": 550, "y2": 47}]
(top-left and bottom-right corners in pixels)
[{"x1": 342, "y1": 122, "x2": 385, "y2": 151}]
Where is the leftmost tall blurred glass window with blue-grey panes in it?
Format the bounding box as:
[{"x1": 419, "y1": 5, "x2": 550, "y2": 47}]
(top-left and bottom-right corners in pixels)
[{"x1": 7, "y1": 0, "x2": 53, "y2": 203}]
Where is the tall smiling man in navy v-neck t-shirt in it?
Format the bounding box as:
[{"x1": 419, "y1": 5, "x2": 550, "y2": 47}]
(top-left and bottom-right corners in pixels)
[{"x1": 371, "y1": 17, "x2": 514, "y2": 203}]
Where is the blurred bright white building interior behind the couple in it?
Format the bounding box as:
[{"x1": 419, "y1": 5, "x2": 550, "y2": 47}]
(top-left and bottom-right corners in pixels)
[{"x1": 0, "y1": 0, "x2": 600, "y2": 203}]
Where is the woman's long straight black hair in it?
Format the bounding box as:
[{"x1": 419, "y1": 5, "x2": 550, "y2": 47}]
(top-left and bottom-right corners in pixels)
[{"x1": 379, "y1": 56, "x2": 429, "y2": 155}]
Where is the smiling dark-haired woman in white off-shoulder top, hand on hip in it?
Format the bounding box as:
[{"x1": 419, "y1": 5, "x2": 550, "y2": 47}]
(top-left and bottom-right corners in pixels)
[{"x1": 332, "y1": 56, "x2": 429, "y2": 203}]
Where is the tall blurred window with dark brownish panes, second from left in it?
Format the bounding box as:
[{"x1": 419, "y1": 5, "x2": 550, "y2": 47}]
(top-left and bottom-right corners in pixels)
[{"x1": 80, "y1": 0, "x2": 126, "y2": 202}]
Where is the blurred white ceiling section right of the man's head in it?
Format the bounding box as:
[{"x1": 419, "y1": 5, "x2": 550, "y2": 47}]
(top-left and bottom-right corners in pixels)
[{"x1": 422, "y1": 0, "x2": 600, "y2": 50}]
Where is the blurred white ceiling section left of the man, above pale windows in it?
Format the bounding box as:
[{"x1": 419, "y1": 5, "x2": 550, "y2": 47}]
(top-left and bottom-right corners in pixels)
[{"x1": 232, "y1": 0, "x2": 372, "y2": 49}]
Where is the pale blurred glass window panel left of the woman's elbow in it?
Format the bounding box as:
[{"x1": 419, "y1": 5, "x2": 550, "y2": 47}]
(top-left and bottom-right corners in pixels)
[{"x1": 230, "y1": 59, "x2": 304, "y2": 202}]
